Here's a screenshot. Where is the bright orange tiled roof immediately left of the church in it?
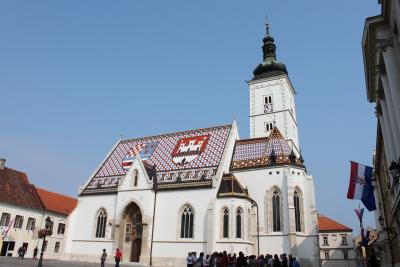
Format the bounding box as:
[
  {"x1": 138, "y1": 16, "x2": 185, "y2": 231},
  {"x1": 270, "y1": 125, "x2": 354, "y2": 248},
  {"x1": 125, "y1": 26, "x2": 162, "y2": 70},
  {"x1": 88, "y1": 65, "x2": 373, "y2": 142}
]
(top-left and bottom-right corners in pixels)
[{"x1": 36, "y1": 187, "x2": 77, "y2": 215}]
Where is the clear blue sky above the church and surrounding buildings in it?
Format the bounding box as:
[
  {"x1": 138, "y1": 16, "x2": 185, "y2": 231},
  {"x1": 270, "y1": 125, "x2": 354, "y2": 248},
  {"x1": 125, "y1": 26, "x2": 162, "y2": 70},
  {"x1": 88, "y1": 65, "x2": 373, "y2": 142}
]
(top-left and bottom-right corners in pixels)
[{"x1": 0, "y1": 0, "x2": 380, "y2": 234}]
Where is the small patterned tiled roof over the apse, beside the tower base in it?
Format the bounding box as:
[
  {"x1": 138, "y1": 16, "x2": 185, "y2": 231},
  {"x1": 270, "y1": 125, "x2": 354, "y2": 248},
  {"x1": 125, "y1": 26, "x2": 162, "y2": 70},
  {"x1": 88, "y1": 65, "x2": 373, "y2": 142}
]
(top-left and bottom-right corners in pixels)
[{"x1": 231, "y1": 127, "x2": 302, "y2": 170}]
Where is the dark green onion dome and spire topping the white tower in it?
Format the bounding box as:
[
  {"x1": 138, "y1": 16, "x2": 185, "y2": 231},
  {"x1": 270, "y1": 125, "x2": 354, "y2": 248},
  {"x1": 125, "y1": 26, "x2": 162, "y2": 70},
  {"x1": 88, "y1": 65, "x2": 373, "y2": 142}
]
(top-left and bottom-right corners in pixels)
[{"x1": 253, "y1": 23, "x2": 288, "y2": 79}]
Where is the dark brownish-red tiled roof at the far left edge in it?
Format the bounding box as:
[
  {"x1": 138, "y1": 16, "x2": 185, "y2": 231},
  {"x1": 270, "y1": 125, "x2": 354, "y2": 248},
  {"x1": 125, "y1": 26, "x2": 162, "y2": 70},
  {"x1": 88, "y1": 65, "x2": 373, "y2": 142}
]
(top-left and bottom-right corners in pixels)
[{"x1": 0, "y1": 168, "x2": 43, "y2": 210}]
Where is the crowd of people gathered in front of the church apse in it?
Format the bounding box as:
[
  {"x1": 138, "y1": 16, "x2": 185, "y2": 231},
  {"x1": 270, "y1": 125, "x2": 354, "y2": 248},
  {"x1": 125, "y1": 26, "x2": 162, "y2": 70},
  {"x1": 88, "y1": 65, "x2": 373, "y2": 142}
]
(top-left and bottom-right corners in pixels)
[{"x1": 186, "y1": 251, "x2": 300, "y2": 267}]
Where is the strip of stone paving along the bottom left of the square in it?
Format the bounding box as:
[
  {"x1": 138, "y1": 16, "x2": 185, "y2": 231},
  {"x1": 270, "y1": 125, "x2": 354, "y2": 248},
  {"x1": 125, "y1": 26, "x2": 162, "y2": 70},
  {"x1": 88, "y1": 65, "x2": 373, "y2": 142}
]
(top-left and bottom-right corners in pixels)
[{"x1": 0, "y1": 257, "x2": 145, "y2": 267}]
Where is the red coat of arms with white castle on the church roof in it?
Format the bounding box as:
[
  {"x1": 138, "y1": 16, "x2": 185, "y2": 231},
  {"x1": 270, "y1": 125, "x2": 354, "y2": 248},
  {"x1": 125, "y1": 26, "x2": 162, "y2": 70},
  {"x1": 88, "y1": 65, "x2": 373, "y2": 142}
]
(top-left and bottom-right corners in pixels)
[{"x1": 171, "y1": 135, "x2": 208, "y2": 165}]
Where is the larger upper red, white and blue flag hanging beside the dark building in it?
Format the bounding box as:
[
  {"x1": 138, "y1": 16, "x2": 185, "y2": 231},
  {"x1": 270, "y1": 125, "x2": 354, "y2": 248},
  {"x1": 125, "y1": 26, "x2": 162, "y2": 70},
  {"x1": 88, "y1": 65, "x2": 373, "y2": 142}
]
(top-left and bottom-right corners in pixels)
[{"x1": 347, "y1": 161, "x2": 376, "y2": 211}]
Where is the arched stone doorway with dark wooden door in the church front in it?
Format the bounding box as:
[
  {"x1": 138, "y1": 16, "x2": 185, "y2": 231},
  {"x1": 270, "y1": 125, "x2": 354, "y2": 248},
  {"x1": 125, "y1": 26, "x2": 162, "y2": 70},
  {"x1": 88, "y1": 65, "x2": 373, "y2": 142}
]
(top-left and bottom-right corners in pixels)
[{"x1": 123, "y1": 202, "x2": 143, "y2": 262}]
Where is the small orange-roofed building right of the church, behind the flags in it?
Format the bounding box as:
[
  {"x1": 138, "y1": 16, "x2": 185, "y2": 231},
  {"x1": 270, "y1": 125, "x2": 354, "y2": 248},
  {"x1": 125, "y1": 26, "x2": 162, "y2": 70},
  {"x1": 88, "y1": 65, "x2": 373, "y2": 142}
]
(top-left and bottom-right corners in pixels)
[{"x1": 318, "y1": 214, "x2": 356, "y2": 267}]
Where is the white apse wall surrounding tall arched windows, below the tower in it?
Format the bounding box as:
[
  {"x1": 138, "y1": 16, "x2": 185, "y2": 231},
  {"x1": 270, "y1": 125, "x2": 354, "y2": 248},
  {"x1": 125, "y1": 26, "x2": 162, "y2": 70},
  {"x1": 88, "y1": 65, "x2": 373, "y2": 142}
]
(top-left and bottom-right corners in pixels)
[{"x1": 234, "y1": 167, "x2": 319, "y2": 261}]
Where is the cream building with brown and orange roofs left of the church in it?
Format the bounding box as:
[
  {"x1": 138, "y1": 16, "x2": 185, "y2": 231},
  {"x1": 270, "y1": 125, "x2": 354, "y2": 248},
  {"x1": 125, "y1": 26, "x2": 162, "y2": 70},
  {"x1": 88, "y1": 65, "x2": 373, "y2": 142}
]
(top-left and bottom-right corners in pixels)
[{"x1": 0, "y1": 160, "x2": 76, "y2": 258}]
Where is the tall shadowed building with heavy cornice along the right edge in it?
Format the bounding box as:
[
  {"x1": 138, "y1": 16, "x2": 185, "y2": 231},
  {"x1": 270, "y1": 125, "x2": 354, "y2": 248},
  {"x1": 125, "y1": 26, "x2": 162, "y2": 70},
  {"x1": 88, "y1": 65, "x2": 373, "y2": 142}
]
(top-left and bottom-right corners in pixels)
[{"x1": 362, "y1": 0, "x2": 400, "y2": 266}]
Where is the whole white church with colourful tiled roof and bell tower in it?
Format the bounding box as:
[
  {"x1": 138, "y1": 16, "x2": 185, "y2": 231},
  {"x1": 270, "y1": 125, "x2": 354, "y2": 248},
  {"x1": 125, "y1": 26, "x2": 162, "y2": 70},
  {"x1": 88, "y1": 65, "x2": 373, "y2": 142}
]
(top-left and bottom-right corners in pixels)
[{"x1": 65, "y1": 26, "x2": 319, "y2": 266}]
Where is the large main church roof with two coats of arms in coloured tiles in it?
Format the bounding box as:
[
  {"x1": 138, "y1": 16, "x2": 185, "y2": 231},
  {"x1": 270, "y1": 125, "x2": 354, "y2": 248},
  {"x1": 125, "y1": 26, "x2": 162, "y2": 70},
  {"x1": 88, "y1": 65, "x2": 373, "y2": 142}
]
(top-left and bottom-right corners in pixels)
[{"x1": 83, "y1": 125, "x2": 231, "y2": 194}]
